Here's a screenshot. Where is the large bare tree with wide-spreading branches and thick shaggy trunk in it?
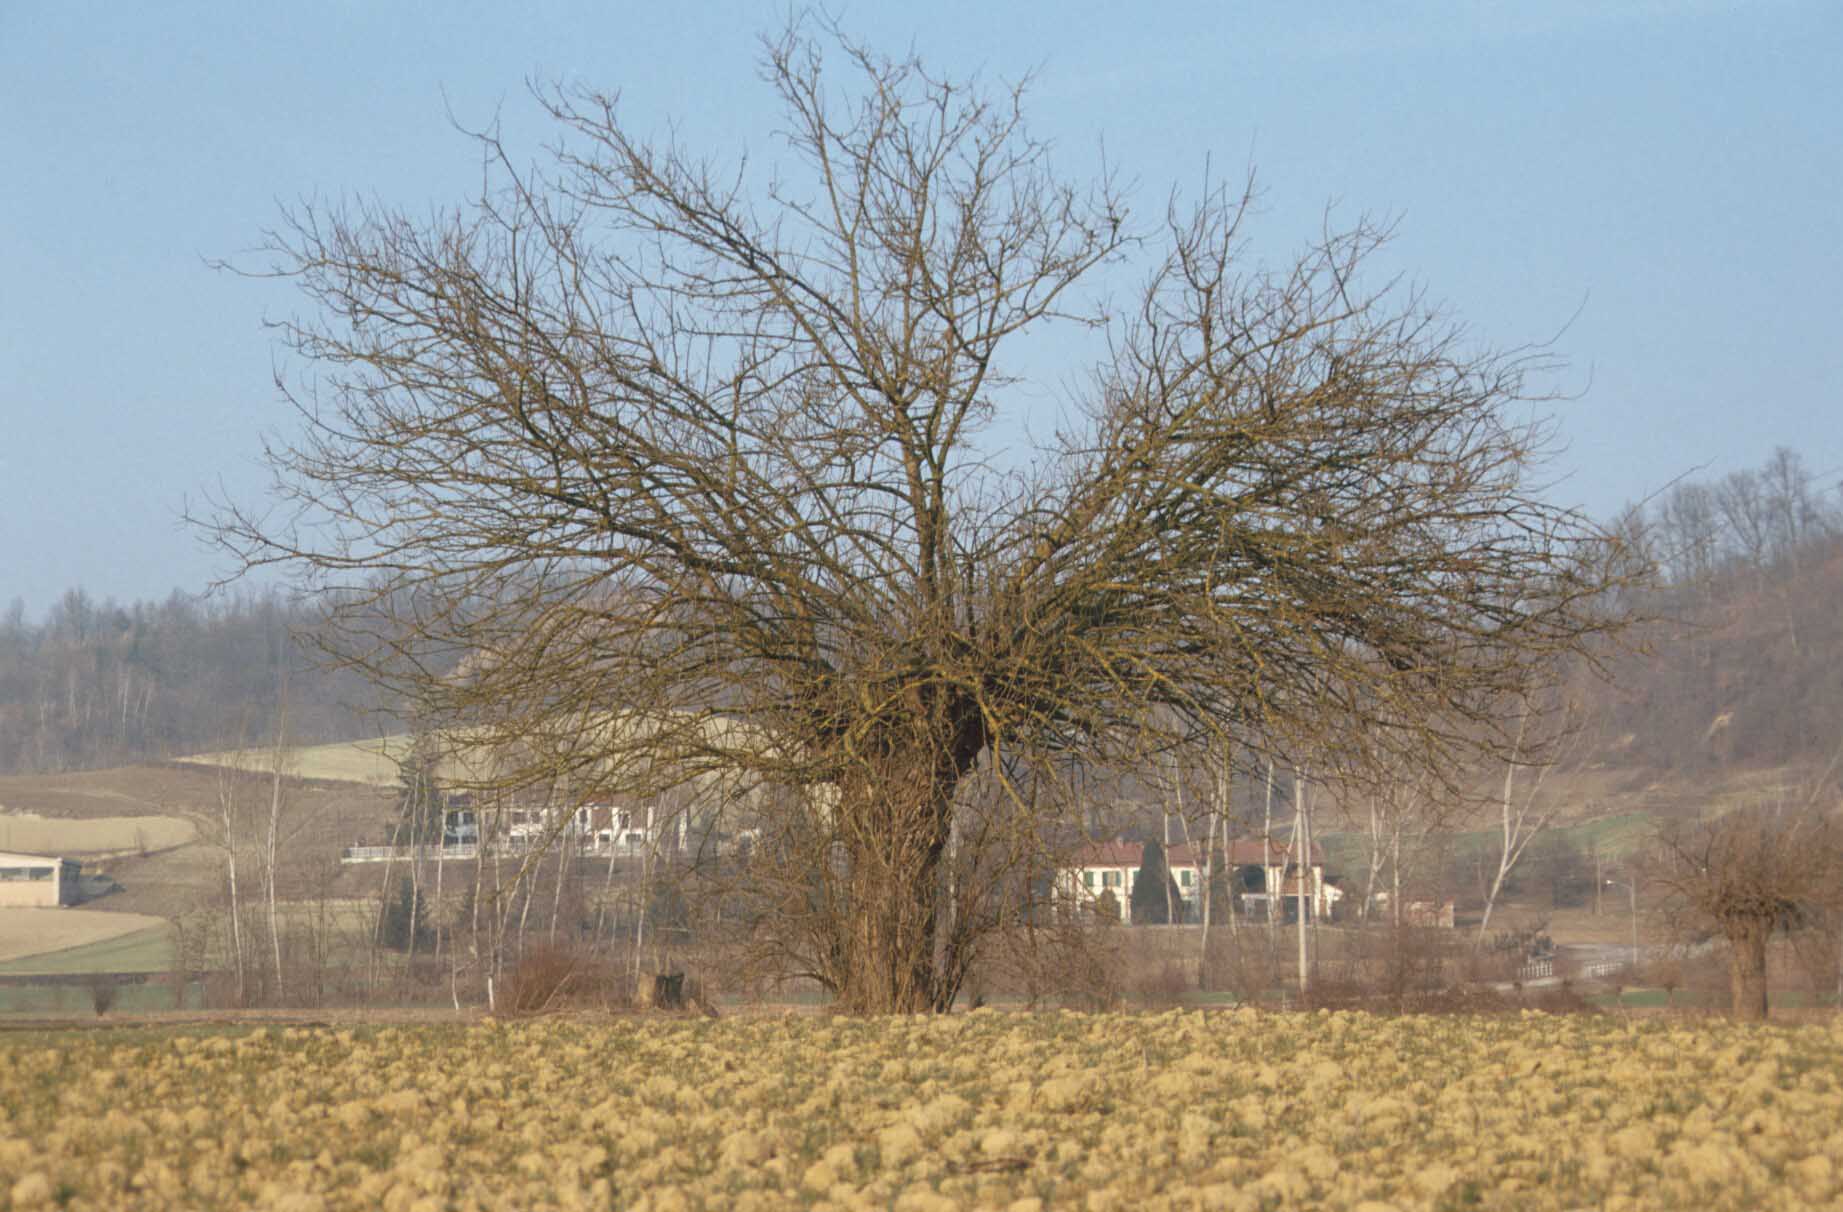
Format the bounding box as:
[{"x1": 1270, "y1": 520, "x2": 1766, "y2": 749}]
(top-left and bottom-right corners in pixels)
[{"x1": 214, "y1": 22, "x2": 1609, "y2": 1011}]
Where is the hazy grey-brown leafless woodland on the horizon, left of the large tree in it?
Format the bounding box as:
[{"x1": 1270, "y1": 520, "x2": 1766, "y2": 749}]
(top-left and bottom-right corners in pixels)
[{"x1": 0, "y1": 588, "x2": 376, "y2": 774}]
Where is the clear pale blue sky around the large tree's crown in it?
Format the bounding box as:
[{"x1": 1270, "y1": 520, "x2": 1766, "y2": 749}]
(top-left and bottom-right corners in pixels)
[{"x1": 0, "y1": 0, "x2": 1843, "y2": 617}]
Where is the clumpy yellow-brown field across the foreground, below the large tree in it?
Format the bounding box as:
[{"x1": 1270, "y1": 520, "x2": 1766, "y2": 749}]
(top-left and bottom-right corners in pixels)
[{"x1": 0, "y1": 1011, "x2": 1843, "y2": 1212}]
